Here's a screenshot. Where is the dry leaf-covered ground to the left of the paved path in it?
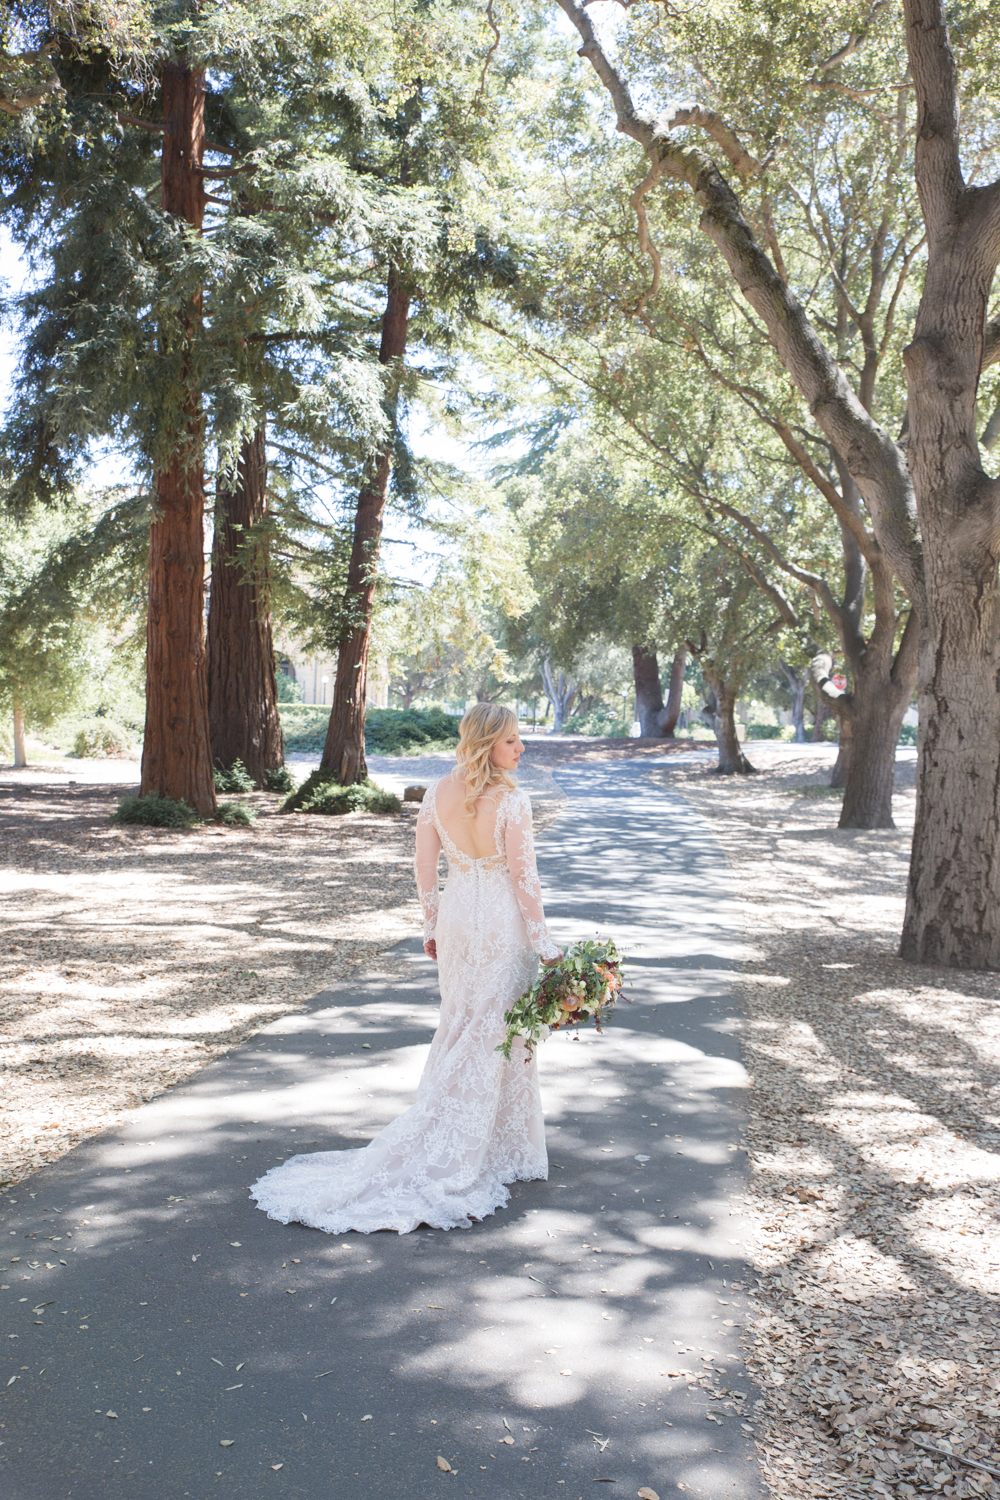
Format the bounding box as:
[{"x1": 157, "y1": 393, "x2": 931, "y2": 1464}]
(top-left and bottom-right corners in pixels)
[{"x1": 0, "y1": 785, "x2": 420, "y2": 1187}]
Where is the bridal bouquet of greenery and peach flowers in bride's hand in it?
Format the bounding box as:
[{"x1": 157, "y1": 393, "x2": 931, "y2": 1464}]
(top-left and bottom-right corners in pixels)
[{"x1": 496, "y1": 938, "x2": 628, "y2": 1062}]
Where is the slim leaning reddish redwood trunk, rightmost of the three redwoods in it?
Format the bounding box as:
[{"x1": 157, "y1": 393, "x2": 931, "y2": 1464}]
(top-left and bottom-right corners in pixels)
[{"x1": 319, "y1": 270, "x2": 409, "y2": 786}]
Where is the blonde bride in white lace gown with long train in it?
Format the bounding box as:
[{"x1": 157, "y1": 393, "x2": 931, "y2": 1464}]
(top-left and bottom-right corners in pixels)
[{"x1": 250, "y1": 704, "x2": 562, "y2": 1235}]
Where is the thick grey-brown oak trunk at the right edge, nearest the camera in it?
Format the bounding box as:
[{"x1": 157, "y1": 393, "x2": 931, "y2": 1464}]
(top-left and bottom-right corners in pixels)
[{"x1": 901, "y1": 0, "x2": 1000, "y2": 969}]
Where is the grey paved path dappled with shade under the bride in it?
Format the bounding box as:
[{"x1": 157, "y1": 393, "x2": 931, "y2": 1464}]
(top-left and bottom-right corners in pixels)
[{"x1": 0, "y1": 764, "x2": 762, "y2": 1500}]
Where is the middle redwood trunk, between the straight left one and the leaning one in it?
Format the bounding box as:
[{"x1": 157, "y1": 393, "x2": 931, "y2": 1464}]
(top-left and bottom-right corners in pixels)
[{"x1": 208, "y1": 423, "x2": 283, "y2": 786}]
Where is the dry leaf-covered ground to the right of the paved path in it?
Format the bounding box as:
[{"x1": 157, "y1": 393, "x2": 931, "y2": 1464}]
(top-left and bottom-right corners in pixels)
[{"x1": 665, "y1": 759, "x2": 1000, "y2": 1497}]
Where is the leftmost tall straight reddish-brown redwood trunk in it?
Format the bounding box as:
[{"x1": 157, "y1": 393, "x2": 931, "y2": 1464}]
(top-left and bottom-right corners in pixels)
[{"x1": 139, "y1": 63, "x2": 216, "y2": 816}]
